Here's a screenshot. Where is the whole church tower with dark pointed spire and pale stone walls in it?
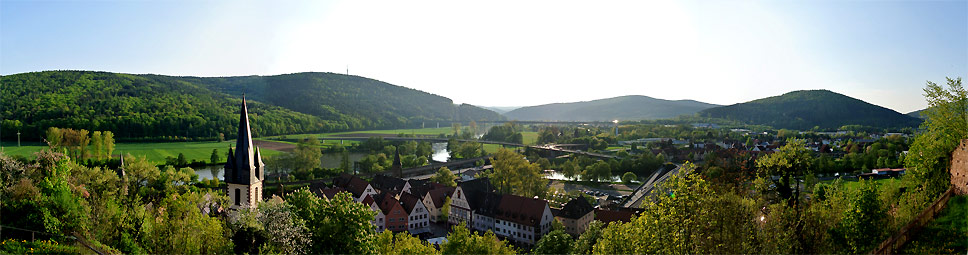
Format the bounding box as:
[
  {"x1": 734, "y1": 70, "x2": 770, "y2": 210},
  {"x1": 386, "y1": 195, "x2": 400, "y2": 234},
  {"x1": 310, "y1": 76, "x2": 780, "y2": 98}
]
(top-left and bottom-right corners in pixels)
[{"x1": 225, "y1": 95, "x2": 265, "y2": 210}]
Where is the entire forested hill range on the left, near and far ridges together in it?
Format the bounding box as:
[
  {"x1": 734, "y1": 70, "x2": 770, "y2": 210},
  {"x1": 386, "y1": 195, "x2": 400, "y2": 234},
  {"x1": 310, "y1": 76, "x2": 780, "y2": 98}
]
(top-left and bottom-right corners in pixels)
[{"x1": 0, "y1": 71, "x2": 503, "y2": 140}]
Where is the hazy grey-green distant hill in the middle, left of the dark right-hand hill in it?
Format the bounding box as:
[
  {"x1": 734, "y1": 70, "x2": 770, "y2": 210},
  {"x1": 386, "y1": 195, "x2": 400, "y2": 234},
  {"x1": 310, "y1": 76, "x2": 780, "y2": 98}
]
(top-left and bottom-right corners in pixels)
[{"x1": 504, "y1": 96, "x2": 718, "y2": 121}]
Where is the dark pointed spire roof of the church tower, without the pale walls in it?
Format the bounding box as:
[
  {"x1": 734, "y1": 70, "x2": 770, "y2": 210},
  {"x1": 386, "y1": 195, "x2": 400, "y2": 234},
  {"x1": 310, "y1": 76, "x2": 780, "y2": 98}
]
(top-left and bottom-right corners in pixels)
[{"x1": 225, "y1": 95, "x2": 265, "y2": 184}]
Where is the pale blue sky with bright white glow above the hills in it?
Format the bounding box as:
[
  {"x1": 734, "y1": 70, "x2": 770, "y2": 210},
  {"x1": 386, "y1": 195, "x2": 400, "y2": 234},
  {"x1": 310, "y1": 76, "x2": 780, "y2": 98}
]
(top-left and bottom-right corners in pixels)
[{"x1": 0, "y1": 0, "x2": 968, "y2": 113}]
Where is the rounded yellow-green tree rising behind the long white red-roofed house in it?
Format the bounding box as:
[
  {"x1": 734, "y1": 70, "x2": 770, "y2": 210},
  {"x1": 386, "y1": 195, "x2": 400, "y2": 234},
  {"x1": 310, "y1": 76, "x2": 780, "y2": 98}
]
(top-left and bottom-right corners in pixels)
[{"x1": 489, "y1": 148, "x2": 548, "y2": 197}]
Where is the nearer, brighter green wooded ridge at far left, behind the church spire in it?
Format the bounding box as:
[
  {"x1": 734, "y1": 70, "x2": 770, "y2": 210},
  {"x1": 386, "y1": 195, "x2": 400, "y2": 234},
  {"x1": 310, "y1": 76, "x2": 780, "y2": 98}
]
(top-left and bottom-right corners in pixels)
[{"x1": 0, "y1": 71, "x2": 328, "y2": 140}]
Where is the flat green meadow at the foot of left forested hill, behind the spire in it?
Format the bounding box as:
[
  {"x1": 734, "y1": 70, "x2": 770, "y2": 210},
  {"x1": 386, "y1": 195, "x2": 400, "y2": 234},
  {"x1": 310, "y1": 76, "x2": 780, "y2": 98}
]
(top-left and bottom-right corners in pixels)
[{"x1": 3, "y1": 141, "x2": 282, "y2": 164}]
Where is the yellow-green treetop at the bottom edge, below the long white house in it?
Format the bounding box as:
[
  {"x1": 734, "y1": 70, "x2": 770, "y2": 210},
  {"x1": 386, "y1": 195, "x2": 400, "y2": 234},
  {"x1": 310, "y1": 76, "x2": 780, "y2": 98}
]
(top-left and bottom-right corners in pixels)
[{"x1": 440, "y1": 222, "x2": 515, "y2": 254}]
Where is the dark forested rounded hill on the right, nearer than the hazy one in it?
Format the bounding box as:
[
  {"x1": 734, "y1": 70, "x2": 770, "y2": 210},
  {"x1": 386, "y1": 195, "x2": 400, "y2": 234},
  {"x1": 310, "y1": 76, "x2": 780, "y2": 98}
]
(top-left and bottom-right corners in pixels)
[{"x1": 699, "y1": 90, "x2": 921, "y2": 130}]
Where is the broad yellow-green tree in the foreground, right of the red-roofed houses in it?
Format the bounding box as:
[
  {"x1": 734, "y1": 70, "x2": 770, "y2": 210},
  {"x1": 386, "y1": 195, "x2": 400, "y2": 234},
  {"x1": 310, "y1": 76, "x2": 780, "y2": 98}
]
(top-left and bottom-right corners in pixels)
[{"x1": 594, "y1": 163, "x2": 758, "y2": 254}]
